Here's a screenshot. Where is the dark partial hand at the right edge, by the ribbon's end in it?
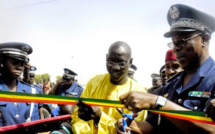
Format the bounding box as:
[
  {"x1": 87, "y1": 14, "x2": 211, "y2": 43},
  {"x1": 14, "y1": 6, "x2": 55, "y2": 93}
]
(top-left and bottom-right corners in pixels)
[{"x1": 206, "y1": 99, "x2": 215, "y2": 121}]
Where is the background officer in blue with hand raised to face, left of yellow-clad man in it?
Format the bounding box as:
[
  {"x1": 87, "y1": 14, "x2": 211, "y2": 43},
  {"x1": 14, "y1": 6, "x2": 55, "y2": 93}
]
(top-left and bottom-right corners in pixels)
[{"x1": 49, "y1": 68, "x2": 83, "y2": 117}]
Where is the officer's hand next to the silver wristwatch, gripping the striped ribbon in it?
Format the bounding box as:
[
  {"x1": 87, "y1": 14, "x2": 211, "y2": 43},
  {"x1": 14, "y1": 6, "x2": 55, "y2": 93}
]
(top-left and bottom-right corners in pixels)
[{"x1": 119, "y1": 91, "x2": 158, "y2": 113}]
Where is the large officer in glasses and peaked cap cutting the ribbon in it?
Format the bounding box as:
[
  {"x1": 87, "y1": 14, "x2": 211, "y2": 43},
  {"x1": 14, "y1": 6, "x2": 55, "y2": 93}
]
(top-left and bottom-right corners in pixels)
[{"x1": 117, "y1": 4, "x2": 215, "y2": 134}]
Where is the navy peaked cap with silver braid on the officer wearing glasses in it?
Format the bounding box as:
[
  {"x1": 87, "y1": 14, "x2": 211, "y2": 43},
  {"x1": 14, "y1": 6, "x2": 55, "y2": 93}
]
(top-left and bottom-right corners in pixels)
[{"x1": 164, "y1": 4, "x2": 215, "y2": 37}]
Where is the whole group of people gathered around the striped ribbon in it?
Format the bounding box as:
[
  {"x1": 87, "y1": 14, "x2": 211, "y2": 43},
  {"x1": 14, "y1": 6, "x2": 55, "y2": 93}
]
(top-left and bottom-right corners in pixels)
[{"x1": 0, "y1": 4, "x2": 215, "y2": 134}]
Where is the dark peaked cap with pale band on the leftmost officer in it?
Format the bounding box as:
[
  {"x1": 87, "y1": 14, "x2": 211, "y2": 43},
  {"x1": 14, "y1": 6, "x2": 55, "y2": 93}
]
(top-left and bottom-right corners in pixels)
[{"x1": 0, "y1": 42, "x2": 33, "y2": 62}]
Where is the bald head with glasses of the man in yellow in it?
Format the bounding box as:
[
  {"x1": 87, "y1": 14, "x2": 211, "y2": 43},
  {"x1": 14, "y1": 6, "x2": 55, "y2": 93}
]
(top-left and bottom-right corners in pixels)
[{"x1": 106, "y1": 41, "x2": 132, "y2": 85}]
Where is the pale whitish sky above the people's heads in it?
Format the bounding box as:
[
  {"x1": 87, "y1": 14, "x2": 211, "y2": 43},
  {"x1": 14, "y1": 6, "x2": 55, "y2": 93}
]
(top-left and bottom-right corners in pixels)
[{"x1": 0, "y1": 0, "x2": 215, "y2": 87}]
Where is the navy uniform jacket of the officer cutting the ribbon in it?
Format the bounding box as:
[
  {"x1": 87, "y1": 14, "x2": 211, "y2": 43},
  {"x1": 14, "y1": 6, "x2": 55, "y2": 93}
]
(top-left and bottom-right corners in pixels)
[{"x1": 147, "y1": 57, "x2": 215, "y2": 134}]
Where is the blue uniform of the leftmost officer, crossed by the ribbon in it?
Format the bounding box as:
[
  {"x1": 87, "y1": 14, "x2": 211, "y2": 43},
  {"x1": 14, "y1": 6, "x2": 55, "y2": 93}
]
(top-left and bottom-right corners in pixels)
[{"x1": 0, "y1": 79, "x2": 38, "y2": 126}]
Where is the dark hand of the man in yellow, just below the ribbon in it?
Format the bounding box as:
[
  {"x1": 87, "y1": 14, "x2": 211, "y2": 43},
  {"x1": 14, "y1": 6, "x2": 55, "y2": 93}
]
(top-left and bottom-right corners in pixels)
[{"x1": 77, "y1": 101, "x2": 102, "y2": 122}]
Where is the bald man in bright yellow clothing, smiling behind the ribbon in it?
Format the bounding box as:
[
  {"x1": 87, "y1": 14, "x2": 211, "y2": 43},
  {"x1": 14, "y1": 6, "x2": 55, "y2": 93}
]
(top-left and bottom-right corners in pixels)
[{"x1": 72, "y1": 41, "x2": 146, "y2": 134}]
